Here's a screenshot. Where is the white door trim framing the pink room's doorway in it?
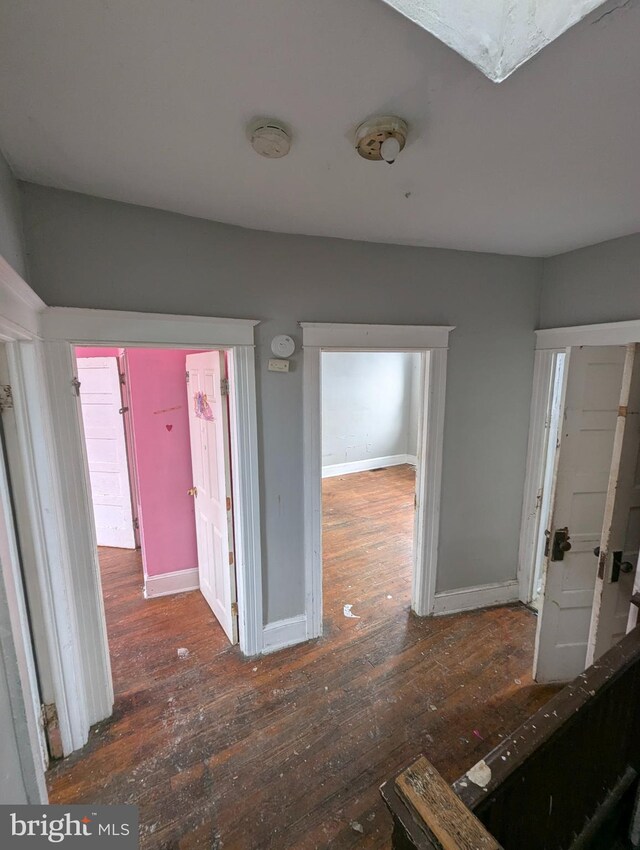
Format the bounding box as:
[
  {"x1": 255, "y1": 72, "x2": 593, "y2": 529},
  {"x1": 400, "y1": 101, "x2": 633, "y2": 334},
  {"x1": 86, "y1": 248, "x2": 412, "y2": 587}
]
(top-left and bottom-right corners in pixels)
[{"x1": 40, "y1": 308, "x2": 263, "y2": 748}]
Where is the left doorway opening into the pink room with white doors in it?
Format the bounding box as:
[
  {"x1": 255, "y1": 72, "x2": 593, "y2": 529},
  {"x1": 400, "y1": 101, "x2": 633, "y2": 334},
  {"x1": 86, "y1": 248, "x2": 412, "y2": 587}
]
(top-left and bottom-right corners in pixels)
[{"x1": 70, "y1": 346, "x2": 238, "y2": 698}]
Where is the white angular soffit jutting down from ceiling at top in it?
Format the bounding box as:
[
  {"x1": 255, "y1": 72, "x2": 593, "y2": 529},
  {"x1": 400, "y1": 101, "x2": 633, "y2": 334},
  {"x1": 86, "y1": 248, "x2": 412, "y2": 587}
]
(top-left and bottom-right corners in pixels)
[{"x1": 384, "y1": 0, "x2": 605, "y2": 83}]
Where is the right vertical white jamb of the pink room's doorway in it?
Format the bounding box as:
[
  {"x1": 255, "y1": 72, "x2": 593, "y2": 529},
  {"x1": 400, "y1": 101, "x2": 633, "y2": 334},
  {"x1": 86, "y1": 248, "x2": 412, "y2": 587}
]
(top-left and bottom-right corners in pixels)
[{"x1": 227, "y1": 345, "x2": 264, "y2": 655}]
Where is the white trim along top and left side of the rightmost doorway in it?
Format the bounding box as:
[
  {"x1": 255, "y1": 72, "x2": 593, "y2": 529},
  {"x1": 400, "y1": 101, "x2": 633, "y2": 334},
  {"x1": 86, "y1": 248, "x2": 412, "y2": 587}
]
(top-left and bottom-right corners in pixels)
[{"x1": 518, "y1": 319, "x2": 640, "y2": 604}]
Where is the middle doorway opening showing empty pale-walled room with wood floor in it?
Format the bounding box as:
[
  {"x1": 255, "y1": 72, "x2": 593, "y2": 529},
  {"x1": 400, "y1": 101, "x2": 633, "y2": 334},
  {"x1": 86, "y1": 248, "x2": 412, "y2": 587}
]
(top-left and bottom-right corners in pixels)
[{"x1": 321, "y1": 351, "x2": 423, "y2": 634}]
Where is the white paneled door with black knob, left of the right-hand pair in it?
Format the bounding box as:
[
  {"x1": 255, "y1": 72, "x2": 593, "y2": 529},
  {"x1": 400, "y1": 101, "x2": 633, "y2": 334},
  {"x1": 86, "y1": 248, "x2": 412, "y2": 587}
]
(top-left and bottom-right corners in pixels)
[{"x1": 534, "y1": 346, "x2": 625, "y2": 682}]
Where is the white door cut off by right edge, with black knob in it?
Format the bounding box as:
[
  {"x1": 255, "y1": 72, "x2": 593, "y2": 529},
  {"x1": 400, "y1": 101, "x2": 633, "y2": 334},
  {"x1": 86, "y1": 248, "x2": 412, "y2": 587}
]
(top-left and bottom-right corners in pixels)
[{"x1": 587, "y1": 344, "x2": 640, "y2": 666}]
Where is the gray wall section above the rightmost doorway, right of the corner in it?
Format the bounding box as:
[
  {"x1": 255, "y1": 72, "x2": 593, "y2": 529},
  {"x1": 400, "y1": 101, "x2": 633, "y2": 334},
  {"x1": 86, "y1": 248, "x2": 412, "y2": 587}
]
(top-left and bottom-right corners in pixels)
[{"x1": 540, "y1": 233, "x2": 640, "y2": 328}]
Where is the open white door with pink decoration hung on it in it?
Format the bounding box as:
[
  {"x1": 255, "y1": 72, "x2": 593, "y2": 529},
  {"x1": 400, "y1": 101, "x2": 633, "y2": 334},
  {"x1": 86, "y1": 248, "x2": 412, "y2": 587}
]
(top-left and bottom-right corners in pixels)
[{"x1": 187, "y1": 351, "x2": 238, "y2": 643}]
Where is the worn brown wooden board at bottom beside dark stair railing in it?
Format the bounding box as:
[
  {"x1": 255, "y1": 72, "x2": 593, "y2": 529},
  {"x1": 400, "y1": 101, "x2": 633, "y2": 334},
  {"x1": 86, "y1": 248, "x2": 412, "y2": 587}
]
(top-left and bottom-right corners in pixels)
[{"x1": 396, "y1": 756, "x2": 500, "y2": 850}]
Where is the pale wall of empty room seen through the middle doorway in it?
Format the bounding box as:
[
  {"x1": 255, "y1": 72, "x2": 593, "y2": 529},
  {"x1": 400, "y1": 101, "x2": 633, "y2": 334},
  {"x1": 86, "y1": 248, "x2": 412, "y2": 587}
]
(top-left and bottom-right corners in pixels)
[{"x1": 322, "y1": 351, "x2": 420, "y2": 467}]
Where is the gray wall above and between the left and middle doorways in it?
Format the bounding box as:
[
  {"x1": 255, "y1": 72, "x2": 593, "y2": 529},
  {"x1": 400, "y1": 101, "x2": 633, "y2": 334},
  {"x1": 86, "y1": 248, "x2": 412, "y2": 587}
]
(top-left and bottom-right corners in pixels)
[{"x1": 22, "y1": 184, "x2": 541, "y2": 608}]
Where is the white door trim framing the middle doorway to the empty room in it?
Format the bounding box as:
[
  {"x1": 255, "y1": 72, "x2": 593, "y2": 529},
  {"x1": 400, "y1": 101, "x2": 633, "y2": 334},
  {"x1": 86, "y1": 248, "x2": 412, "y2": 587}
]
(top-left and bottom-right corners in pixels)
[{"x1": 300, "y1": 322, "x2": 453, "y2": 639}]
